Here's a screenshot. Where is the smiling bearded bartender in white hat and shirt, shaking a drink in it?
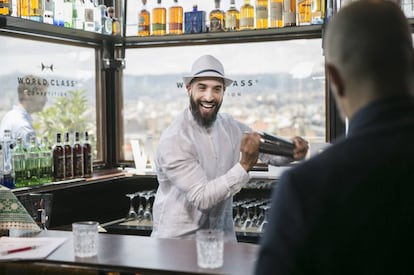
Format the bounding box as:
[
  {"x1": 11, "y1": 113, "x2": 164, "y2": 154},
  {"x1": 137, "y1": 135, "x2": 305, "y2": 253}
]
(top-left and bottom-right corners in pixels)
[{"x1": 151, "y1": 55, "x2": 308, "y2": 242}]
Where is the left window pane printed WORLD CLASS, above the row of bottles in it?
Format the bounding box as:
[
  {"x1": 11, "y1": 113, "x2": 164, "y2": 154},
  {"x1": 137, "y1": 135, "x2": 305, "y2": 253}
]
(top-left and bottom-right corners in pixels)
[{"x1": 0, "y1": 36, "x2": 102, "y2": 163}]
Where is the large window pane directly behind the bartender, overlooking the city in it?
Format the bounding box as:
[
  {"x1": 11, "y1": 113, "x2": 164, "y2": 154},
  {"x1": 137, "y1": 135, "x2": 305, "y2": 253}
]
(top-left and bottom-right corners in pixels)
[{"x1": 120, "y1": 39, "x2": 326, "y2": 164}]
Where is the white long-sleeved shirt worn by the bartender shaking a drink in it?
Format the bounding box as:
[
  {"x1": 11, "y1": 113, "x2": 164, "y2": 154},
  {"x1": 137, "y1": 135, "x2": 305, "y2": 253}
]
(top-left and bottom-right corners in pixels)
[{"x1": 152, "y1": 109, "x2": 291, "y2": 241}]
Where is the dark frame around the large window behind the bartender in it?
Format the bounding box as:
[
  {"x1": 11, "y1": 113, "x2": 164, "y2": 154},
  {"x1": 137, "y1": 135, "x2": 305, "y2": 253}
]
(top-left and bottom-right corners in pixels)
[{"x1": 115, "y1": 25, "x2": 345, "y2": 167}]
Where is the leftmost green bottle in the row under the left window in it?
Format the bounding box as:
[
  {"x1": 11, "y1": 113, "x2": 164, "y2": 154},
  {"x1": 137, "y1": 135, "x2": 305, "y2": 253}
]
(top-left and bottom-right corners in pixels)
[{"x1": 12, "y1": 137, "x2": 28, "y2": 188}]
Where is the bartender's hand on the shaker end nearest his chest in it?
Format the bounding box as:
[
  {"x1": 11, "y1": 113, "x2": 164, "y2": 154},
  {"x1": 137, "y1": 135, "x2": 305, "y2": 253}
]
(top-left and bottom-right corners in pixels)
[{"x1": 240, "y1": 132, "x2": 260, "y2": 172}]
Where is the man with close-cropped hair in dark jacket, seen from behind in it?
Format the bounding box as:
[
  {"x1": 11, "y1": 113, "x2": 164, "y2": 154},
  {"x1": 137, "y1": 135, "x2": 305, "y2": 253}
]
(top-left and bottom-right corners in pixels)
[{"x1": 255, "y1": 0, "x2": 414, "y2": 275}]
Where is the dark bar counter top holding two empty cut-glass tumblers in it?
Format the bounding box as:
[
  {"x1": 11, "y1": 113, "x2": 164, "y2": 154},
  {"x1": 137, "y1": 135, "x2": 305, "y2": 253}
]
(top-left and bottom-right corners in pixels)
[{"x1": 0, "y1": 230, "x2": 258, "y2": 275}]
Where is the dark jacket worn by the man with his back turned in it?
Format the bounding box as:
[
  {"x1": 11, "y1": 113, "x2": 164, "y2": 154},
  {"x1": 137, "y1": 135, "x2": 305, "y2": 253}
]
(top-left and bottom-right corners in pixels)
[{"x1": 256, "y1": 97, "x2": 414, "y2": 275}]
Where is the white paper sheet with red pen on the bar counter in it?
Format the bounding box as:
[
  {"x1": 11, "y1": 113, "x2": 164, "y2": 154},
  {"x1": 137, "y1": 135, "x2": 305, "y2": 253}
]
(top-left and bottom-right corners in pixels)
[{"x1": 0, "y1": 237, "x2": 67, "y2": 261}]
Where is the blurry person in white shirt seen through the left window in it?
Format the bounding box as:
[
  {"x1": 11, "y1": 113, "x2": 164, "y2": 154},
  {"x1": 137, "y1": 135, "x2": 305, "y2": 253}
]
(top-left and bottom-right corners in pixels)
[{"x1": 0, "y1": 75, "x2": 47, "y2": 147}]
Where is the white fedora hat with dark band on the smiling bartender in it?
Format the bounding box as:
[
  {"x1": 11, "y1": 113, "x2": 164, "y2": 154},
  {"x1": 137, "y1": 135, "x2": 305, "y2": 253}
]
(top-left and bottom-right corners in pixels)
[{"x1": 183, "y1": 55, "x2": 233, "y2": 87}]
